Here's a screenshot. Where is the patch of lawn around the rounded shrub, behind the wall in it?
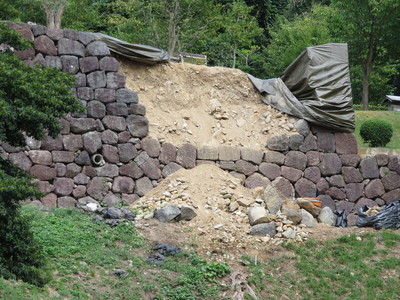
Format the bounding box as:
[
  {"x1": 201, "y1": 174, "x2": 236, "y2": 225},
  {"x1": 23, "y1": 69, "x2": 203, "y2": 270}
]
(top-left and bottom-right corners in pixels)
[{"x1": 354, "y1": 111, "x2": 400, "y2": 149}]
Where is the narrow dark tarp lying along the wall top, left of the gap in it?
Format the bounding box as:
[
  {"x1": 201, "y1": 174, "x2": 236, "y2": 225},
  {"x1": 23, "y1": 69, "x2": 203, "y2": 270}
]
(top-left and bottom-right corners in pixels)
[{"x1": 94, "y1": 33, "x2": 169, "y2": 64}]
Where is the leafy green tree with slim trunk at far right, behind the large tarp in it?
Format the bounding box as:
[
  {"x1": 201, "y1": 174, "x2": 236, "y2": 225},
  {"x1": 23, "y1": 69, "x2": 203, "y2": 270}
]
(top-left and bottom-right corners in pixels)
[{"x1": 332, "y1": 0, "x2": 400, "y2": 110}]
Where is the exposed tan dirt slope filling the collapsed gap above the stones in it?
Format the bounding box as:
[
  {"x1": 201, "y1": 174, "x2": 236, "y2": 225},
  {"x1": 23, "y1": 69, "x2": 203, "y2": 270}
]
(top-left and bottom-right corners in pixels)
[{"x1": 120, "y1": 59, "x2": 297, "y2": 150}]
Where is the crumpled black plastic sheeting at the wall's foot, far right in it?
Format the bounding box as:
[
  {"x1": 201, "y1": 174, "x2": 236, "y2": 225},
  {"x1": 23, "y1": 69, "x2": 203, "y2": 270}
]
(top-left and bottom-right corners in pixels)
[{"x1": 356, "y1": 200, "x2": 400, "y2": 229}]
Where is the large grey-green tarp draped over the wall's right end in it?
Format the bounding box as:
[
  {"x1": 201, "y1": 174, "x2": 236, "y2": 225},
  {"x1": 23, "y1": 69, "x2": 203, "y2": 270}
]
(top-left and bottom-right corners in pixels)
[{"x1": 248, "y1": 43, "x2": 355, "y2": 132}]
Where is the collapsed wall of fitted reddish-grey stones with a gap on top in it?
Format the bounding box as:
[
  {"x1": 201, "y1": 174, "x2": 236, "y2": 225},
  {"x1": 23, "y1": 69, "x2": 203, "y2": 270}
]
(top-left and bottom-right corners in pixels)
[{"x1": 0, "y1": 24, "x2": 400, "y2": 223}]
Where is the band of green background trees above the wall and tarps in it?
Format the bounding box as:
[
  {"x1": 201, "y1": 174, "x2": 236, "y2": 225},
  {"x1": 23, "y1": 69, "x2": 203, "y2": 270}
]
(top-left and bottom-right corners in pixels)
[{"x1": 0, "y1": 0, "x2": 400, "y2": 104}]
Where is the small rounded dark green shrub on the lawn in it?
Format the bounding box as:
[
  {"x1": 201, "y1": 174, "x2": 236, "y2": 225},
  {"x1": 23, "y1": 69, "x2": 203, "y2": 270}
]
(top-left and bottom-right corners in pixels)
[{"x1": 360, "y1": 119, "x2": 393, "y2": 147}]
